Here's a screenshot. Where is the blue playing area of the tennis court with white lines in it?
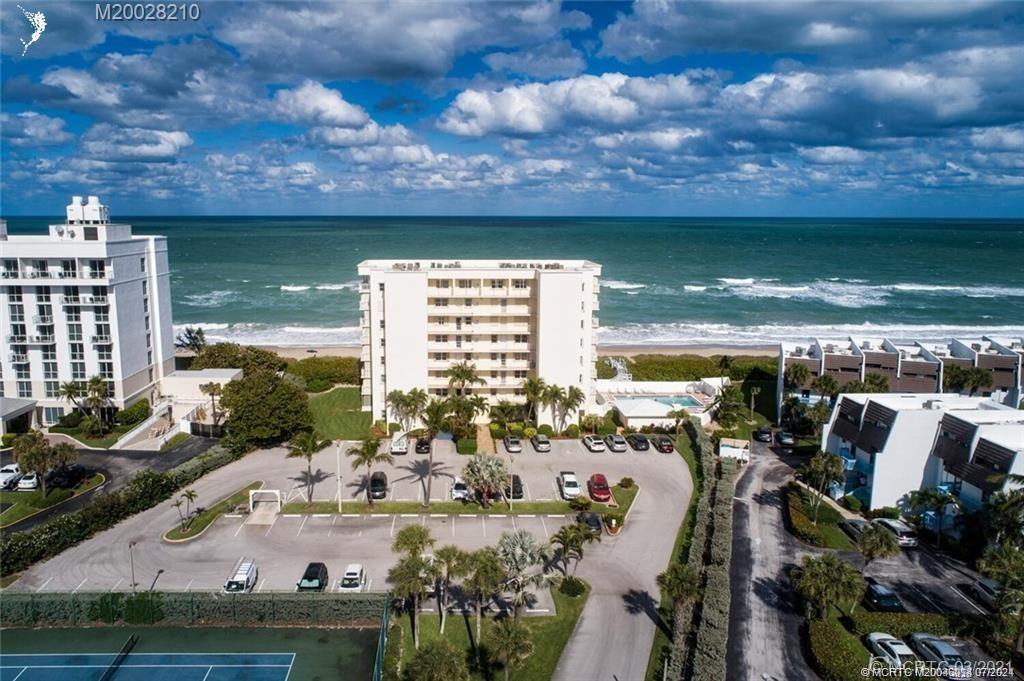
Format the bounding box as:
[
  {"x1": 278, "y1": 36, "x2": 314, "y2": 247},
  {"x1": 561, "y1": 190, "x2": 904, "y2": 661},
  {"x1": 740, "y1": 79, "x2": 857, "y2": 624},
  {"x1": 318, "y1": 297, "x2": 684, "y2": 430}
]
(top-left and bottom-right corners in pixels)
[{"x1": 0, "y1": 652, "x2": 295, "y2": 681}]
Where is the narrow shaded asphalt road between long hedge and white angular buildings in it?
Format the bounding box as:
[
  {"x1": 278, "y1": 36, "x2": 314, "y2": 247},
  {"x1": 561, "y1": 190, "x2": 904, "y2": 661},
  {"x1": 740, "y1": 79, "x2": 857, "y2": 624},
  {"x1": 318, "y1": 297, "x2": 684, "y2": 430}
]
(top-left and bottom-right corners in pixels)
[{"x1": 728, "y1": 442, "x2": 818, "y2": 681}]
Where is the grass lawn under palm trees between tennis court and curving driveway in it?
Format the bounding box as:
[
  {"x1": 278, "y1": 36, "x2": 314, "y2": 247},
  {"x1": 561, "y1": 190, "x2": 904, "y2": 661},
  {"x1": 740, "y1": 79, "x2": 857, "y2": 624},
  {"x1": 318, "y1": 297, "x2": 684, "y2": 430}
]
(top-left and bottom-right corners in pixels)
[{"x1": 400, "y1": 586, "x2": 590, "y2": 681}]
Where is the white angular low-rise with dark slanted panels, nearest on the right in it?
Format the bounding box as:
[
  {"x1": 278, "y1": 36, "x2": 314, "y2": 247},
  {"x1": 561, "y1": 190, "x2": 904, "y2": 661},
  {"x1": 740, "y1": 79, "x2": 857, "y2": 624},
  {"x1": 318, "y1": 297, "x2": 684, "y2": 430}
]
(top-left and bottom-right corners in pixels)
[{"x1": 821, "y1": 392, "x2": 1024, "y2": 510}]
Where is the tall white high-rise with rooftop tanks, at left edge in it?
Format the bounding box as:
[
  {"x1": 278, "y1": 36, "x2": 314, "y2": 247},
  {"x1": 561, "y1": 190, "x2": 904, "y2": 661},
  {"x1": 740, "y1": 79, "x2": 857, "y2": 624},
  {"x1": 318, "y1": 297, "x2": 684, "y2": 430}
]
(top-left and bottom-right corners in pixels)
[{"x1": 0, "y1": 197, "x2": 174, "y2": 425}]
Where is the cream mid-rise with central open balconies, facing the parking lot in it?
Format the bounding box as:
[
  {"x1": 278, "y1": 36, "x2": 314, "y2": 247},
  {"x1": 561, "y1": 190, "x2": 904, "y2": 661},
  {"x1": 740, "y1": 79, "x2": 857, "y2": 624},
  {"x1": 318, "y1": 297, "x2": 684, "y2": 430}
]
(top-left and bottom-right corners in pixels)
[{"x1": 358, "y1": 259, "x2": 601, "y2": 422}]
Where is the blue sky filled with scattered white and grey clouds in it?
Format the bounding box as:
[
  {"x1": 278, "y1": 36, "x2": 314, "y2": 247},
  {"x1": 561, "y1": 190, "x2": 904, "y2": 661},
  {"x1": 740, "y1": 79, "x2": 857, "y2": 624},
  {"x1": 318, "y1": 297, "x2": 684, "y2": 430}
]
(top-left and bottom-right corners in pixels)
[{"x1": 0, "y1": 0, "x2": 1024, "y2": 217}]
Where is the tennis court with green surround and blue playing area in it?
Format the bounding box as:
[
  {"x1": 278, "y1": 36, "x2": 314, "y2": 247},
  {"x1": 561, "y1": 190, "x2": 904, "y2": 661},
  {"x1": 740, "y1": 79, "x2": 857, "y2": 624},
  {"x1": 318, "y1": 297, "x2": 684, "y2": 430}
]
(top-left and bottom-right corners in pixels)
[{"x1": 0, "y1": 627, "x2": 379, "y2": 681}]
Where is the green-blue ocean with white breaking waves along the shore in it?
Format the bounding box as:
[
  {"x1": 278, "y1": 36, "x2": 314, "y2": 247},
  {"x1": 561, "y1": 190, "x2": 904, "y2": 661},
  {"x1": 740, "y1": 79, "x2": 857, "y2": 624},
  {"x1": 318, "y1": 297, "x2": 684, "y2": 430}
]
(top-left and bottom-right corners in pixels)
[{"x1": 2, "y1": 216, "x2": 1024, "y2": 346}]
